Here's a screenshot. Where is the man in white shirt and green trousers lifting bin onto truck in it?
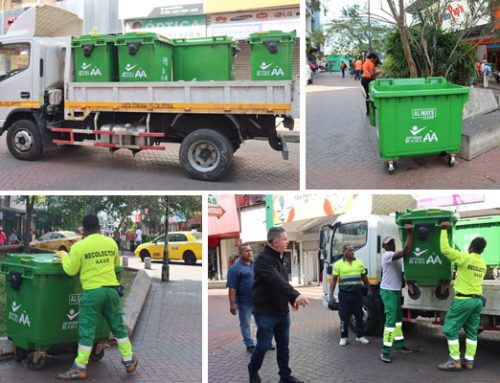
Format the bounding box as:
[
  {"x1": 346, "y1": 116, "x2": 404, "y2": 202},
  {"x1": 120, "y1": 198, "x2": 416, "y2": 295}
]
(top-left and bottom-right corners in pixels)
[{"x1": 380, "y1": 224, "x2": 413, "y2": 363}]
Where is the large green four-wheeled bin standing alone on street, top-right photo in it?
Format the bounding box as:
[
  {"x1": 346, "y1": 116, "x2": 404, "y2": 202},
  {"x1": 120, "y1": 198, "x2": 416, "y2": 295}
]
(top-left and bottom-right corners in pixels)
[{"x1": 369, "y1": 77, "x2": 470, "y2": 173}]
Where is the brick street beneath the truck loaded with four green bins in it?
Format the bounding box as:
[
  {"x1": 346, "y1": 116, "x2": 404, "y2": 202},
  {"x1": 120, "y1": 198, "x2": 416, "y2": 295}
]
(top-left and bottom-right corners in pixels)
[{"x1": 0, "y1": 134, "x2": 300, "y2": 191}]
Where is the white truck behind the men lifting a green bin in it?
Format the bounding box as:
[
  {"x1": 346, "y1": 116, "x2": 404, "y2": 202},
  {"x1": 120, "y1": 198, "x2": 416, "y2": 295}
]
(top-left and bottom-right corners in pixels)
[{"x1": 318, "y1": 214, "x2": 500, "y2": 335}]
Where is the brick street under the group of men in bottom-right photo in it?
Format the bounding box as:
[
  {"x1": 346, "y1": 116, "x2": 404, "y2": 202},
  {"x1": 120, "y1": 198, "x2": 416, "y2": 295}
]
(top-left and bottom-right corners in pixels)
[{"x1": 208, "y1": 288, "x2": 500, "y2": 383}]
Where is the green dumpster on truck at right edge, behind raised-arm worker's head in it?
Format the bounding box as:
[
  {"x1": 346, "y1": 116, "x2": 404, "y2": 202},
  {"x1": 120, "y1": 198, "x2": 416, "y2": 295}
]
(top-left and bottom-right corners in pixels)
[{"x1": 454, "y1": 215, "x2": 500, "y2": 267}]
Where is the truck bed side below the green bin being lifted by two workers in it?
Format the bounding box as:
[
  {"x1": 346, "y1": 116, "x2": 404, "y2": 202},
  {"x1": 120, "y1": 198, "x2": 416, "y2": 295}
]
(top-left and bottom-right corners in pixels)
[{"x1": 402, "y1": 279, "x2": 500, "y2": 315}]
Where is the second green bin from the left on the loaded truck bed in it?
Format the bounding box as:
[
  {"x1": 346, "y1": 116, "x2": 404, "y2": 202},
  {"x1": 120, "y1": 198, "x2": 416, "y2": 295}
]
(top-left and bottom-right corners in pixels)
[{"x1": 115, "y1": 32, "x2": 174, "y2": 82}]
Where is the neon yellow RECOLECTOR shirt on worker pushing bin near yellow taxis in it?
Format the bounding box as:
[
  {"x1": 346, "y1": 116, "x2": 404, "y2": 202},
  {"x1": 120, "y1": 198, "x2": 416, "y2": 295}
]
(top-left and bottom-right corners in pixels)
[{"x1": 62, "y1": 234, "x2": 120, "y2": 290}]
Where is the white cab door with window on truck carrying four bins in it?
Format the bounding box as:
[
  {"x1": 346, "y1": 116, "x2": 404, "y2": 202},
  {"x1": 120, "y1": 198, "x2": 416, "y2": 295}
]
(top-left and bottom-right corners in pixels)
[{"x1": 0, "y1": 42, "x2": 35, "y2": 127}]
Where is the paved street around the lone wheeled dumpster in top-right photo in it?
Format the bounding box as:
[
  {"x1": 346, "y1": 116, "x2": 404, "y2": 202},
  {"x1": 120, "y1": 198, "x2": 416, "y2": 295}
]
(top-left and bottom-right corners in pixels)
[{"x1": 306, "y1": 73, "x2": 500, "y2": 189}]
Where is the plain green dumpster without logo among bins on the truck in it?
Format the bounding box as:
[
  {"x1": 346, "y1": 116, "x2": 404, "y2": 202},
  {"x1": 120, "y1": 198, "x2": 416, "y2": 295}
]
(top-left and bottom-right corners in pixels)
[{"x1": 174, "y1": 36, "x2": 239, "y2": 81}]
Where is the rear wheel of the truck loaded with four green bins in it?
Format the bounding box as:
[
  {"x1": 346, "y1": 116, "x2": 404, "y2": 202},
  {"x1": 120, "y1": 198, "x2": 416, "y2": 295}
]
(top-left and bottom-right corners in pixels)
[{"x1": 179, "y1": 129, "x2": 233, "y2": 181}]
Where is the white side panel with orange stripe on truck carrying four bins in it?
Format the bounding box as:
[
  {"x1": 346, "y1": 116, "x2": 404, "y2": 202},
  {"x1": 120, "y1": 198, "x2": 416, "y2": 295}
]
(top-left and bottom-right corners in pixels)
[{"x1": 64, "y1": 81, "x2": 293, "y2": 120}]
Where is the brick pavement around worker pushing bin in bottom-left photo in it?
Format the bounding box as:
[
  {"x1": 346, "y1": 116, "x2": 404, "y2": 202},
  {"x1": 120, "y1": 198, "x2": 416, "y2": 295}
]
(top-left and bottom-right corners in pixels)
[{"x1": 0, "y1": 254, "x2": 202, "y2": 383}]
